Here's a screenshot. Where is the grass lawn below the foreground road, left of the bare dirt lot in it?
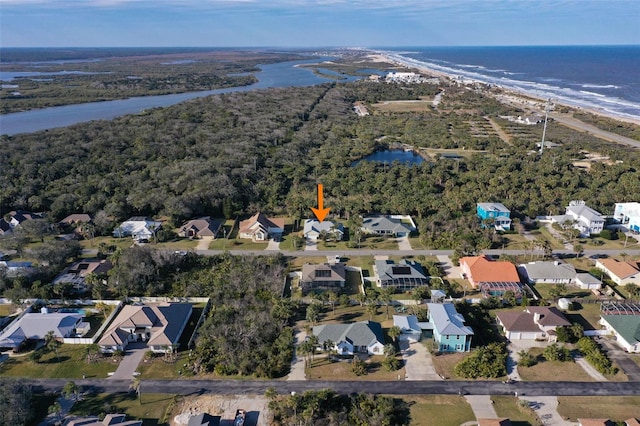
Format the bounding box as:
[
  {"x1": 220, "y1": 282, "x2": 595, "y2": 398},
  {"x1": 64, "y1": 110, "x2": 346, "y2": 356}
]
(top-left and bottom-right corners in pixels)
[{"x1": 71, "y1": 392, "x2": 178, "y2": 426}]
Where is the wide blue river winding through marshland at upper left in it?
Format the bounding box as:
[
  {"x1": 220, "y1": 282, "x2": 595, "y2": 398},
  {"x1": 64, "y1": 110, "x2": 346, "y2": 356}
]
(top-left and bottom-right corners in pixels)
[{"x1": 0, "y1": 58, "x2": 356, "y2": 135}]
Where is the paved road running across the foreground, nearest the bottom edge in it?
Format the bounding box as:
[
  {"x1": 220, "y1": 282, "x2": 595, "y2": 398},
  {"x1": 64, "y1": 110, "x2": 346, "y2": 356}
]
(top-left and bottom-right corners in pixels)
[{"x1": 23, "y1": 379, "x2": 640, "y2": 396}]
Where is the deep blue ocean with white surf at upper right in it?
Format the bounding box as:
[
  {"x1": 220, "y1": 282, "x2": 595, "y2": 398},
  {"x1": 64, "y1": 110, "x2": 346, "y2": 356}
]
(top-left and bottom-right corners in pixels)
[{"x1": 384, "y1": 46, "x2": 640, "y2": 119}]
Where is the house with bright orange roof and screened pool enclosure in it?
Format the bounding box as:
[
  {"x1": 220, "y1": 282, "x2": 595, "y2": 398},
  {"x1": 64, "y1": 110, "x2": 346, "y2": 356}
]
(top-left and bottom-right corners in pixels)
[{"x1": 460, "y1": 256, "x2": 522, "y2": 298}]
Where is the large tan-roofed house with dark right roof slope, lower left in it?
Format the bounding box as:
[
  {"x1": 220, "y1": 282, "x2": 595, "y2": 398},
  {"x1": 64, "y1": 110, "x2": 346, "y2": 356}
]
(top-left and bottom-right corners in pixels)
[{"x1": 98, "y1": 303, "x2": 192, "y2": 353}]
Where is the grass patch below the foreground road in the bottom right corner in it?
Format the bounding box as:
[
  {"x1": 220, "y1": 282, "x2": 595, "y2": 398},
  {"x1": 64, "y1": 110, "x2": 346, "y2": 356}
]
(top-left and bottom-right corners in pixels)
[{"x1": 558, "y1": 396, "x2": 640, "y2": 422}]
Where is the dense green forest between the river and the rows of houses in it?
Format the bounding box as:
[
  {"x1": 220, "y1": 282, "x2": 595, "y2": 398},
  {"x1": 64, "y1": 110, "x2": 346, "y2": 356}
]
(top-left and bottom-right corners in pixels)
[{"x1": 0, "y1": 78, "x2": 640, "y2": 239}]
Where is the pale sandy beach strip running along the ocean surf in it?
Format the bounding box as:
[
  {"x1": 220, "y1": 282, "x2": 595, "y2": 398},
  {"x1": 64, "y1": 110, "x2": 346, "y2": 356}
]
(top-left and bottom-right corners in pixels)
[{"x1": 367, "y1": 53, "x2": 640, "y2": 126}]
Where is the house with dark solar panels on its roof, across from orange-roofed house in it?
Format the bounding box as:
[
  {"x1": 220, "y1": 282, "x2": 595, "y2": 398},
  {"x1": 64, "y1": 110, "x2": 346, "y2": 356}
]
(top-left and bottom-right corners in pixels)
[{"x1": 373, "y1": 259, "x2": 429, "y2": 291}]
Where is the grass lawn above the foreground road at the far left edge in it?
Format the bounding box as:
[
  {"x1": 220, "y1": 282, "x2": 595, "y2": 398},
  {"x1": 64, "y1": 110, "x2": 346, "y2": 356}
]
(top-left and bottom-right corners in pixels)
[{"x1": 0, "y1": 344, "x2": 118, "y2": 379}]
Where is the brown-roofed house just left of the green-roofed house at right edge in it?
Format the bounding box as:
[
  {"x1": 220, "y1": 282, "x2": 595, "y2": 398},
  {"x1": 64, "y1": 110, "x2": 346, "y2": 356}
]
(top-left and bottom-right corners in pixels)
[{"x1": 496, "y1": 306, "x2": 571, "y2": 342}]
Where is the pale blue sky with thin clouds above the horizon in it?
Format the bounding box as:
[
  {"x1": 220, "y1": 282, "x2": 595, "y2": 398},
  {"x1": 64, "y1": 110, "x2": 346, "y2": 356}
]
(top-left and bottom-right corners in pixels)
[{"x1": 0, "y1": 0, "x2": 640, "y2": 47}]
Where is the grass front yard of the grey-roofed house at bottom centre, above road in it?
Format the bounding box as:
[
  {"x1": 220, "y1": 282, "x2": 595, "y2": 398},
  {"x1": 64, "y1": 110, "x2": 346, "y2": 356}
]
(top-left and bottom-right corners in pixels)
[{"x1": 307, "y1": 355, "x2": 405, "y2": 381}]
